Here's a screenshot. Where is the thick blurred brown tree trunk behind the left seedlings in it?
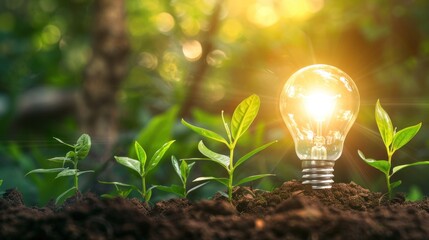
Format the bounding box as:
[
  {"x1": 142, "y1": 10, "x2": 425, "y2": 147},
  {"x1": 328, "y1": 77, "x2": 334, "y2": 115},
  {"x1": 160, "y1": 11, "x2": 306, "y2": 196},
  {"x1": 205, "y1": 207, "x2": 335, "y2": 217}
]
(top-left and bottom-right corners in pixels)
[{"x1": 78, "y1": 0, "x2": 129, "y2": 161}]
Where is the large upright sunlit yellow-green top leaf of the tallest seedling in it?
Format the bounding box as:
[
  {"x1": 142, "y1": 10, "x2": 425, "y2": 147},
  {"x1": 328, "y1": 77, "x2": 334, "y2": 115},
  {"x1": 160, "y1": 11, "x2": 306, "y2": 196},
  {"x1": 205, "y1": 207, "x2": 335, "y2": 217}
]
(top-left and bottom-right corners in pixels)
[{"x1": 231, "y1": 94, "x2": 261, "y2": 141}]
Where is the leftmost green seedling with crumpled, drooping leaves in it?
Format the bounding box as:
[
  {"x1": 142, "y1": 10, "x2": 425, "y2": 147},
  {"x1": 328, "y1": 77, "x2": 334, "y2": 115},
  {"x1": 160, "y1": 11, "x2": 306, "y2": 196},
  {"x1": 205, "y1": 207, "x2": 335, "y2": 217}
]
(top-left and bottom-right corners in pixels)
[{"x1": 26, "y1": 134, "x2": 94, "y2": 203}]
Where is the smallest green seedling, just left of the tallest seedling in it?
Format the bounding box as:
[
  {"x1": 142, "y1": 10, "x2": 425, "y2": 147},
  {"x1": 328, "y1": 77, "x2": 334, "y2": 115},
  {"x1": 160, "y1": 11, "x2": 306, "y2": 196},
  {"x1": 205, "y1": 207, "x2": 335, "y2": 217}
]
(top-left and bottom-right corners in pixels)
[{"x1": 156, "y1": 156, "x2": 208, "y2": 198}]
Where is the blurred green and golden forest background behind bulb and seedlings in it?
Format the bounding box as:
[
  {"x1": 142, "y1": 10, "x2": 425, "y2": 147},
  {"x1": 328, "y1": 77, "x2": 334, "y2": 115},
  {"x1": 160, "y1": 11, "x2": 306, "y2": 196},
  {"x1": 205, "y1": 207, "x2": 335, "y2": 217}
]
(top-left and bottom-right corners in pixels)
[{"x1": 0, "y1": 0, "x2": 429, "y2": 204}]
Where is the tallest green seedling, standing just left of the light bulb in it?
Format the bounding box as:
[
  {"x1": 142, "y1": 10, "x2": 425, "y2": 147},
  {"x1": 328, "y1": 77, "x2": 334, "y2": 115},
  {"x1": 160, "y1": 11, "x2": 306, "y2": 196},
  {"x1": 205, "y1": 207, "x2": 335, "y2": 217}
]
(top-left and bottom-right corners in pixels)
[{"x1": 182, "y1": 94, "x2": 277, "y2": 201}]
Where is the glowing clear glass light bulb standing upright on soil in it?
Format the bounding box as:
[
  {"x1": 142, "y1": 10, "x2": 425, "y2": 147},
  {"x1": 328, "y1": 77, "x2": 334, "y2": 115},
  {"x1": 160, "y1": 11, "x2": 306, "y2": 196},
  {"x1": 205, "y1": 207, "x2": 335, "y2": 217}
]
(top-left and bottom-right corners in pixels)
[{"x1": 280, "y1": 64, "x2": 360, "y2": 189}]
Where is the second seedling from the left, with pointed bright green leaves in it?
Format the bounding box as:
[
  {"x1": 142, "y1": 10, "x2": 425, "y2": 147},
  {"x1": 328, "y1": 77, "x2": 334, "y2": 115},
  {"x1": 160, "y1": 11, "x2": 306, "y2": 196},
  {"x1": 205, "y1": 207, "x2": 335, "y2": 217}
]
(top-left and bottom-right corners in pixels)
[{"x1": 100, "y1": 140, "x2": 174, "y2": 202}]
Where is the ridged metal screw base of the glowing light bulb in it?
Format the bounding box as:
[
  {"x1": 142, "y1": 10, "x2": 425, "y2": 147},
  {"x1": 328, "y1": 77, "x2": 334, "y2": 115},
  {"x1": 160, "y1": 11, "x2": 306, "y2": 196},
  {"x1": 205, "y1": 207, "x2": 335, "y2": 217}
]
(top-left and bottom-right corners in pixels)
[{"x1": 302, "y1": 159, "x2": 335, "y2": 189}]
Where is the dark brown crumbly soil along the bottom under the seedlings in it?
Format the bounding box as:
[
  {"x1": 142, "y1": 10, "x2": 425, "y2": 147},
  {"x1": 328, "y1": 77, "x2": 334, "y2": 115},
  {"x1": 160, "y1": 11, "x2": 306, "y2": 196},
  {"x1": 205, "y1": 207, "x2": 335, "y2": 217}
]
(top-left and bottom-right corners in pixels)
[{"x1": 0, "y1": 181, "x2": 429, "y2": 240}]
